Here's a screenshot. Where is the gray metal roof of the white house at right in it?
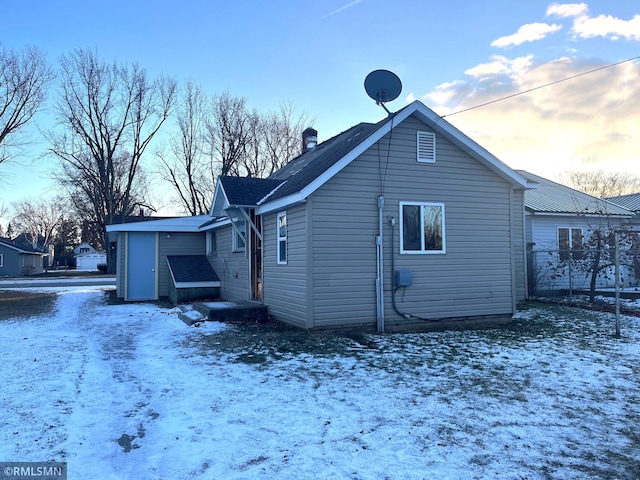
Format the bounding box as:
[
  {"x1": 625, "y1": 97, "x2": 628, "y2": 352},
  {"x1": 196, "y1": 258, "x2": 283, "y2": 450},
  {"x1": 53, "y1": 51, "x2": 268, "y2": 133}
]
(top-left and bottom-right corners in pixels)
[{"x1": 518, "y1": 170, "x2": 633, "y2": 217}]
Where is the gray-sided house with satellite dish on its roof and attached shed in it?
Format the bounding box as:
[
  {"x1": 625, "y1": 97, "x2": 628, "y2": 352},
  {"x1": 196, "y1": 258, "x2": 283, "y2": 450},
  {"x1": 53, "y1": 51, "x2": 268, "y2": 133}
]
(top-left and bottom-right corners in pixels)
[{"x1": 107, "y1": 102, "x2": 529, "y2": 331}]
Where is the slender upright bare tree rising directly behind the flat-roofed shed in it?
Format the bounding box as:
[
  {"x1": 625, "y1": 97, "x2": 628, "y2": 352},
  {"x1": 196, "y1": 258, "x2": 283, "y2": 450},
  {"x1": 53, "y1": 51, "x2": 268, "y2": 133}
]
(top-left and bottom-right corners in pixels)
[{"x1": 156, "y1": 80, "x2": 214, "y2": 215}]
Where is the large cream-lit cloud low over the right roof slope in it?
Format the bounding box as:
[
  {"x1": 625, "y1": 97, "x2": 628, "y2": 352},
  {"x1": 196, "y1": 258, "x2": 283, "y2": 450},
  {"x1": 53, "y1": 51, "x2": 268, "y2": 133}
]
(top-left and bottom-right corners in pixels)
[{"x1": 423, "y1": 56, "x2": 640, "y2": 178}]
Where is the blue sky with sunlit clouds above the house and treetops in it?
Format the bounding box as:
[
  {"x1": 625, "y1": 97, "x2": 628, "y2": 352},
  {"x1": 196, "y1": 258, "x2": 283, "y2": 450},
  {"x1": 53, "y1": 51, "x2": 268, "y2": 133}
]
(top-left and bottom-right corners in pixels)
[{"x1": 0, "y1": 0, "x2": 640, "y2": 222}]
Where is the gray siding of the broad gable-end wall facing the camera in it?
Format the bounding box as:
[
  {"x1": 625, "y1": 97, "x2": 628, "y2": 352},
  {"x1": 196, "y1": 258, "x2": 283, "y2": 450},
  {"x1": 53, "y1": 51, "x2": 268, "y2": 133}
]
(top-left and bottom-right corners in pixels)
[{"x1": 311, "y1": 114, "x2": 524, "y2": 328}]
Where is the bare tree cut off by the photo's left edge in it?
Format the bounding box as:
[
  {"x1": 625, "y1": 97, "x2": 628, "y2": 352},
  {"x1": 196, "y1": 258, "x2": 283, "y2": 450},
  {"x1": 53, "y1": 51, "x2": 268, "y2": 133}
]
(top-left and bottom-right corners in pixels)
[{"x1": 0, "y1": 47, "x2": 54, "y2": 168}]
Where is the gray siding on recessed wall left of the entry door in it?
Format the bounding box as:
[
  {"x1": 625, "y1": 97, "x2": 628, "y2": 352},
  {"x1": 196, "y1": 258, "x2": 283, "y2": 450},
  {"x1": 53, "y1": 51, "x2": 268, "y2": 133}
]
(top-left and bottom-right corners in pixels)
[{"x1": 208, "y1": 225, "x2": 251, "y2": 301}]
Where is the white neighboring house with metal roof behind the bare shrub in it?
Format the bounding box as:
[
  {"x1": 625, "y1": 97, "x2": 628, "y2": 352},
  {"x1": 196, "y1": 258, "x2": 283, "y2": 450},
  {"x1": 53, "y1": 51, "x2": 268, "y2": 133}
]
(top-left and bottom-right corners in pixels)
[{"x1": 518, "y1": 170, "x2": 633, "y2": 295}]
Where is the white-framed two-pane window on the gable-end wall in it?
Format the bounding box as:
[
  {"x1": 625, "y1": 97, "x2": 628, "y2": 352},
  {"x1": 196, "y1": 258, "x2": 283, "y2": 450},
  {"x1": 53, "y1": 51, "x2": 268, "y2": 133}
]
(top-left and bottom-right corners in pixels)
[{"x1": 400, "y1": 202, "x2": 446, "y2": 254}]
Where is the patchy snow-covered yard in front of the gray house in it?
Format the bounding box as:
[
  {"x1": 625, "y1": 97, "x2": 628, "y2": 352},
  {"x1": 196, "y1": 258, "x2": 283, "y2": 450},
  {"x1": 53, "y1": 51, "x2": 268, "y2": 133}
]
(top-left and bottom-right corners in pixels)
[{"x1": 0, "y1": 287, "x2": 640, "y2": 480}]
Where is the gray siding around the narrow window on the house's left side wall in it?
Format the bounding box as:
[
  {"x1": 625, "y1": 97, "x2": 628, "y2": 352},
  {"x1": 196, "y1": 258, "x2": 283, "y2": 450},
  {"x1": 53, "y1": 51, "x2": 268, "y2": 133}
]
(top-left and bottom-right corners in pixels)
[{"x1": 262, "y1": 205, "x2": 312, "y2": 328}]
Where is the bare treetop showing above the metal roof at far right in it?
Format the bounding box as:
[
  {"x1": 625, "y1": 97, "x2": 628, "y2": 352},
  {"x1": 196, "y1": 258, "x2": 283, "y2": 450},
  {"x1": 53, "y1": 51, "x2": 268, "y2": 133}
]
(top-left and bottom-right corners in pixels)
[{"x1": 560, "y1": 170, "x2": 640, "y2": 198}]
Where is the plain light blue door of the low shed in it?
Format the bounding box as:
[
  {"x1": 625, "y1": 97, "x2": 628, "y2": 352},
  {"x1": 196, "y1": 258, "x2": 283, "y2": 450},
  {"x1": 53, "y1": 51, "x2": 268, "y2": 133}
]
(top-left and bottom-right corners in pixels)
[{"x1": 126, "y1": 232, "x2": 157, "y2": 300}]
